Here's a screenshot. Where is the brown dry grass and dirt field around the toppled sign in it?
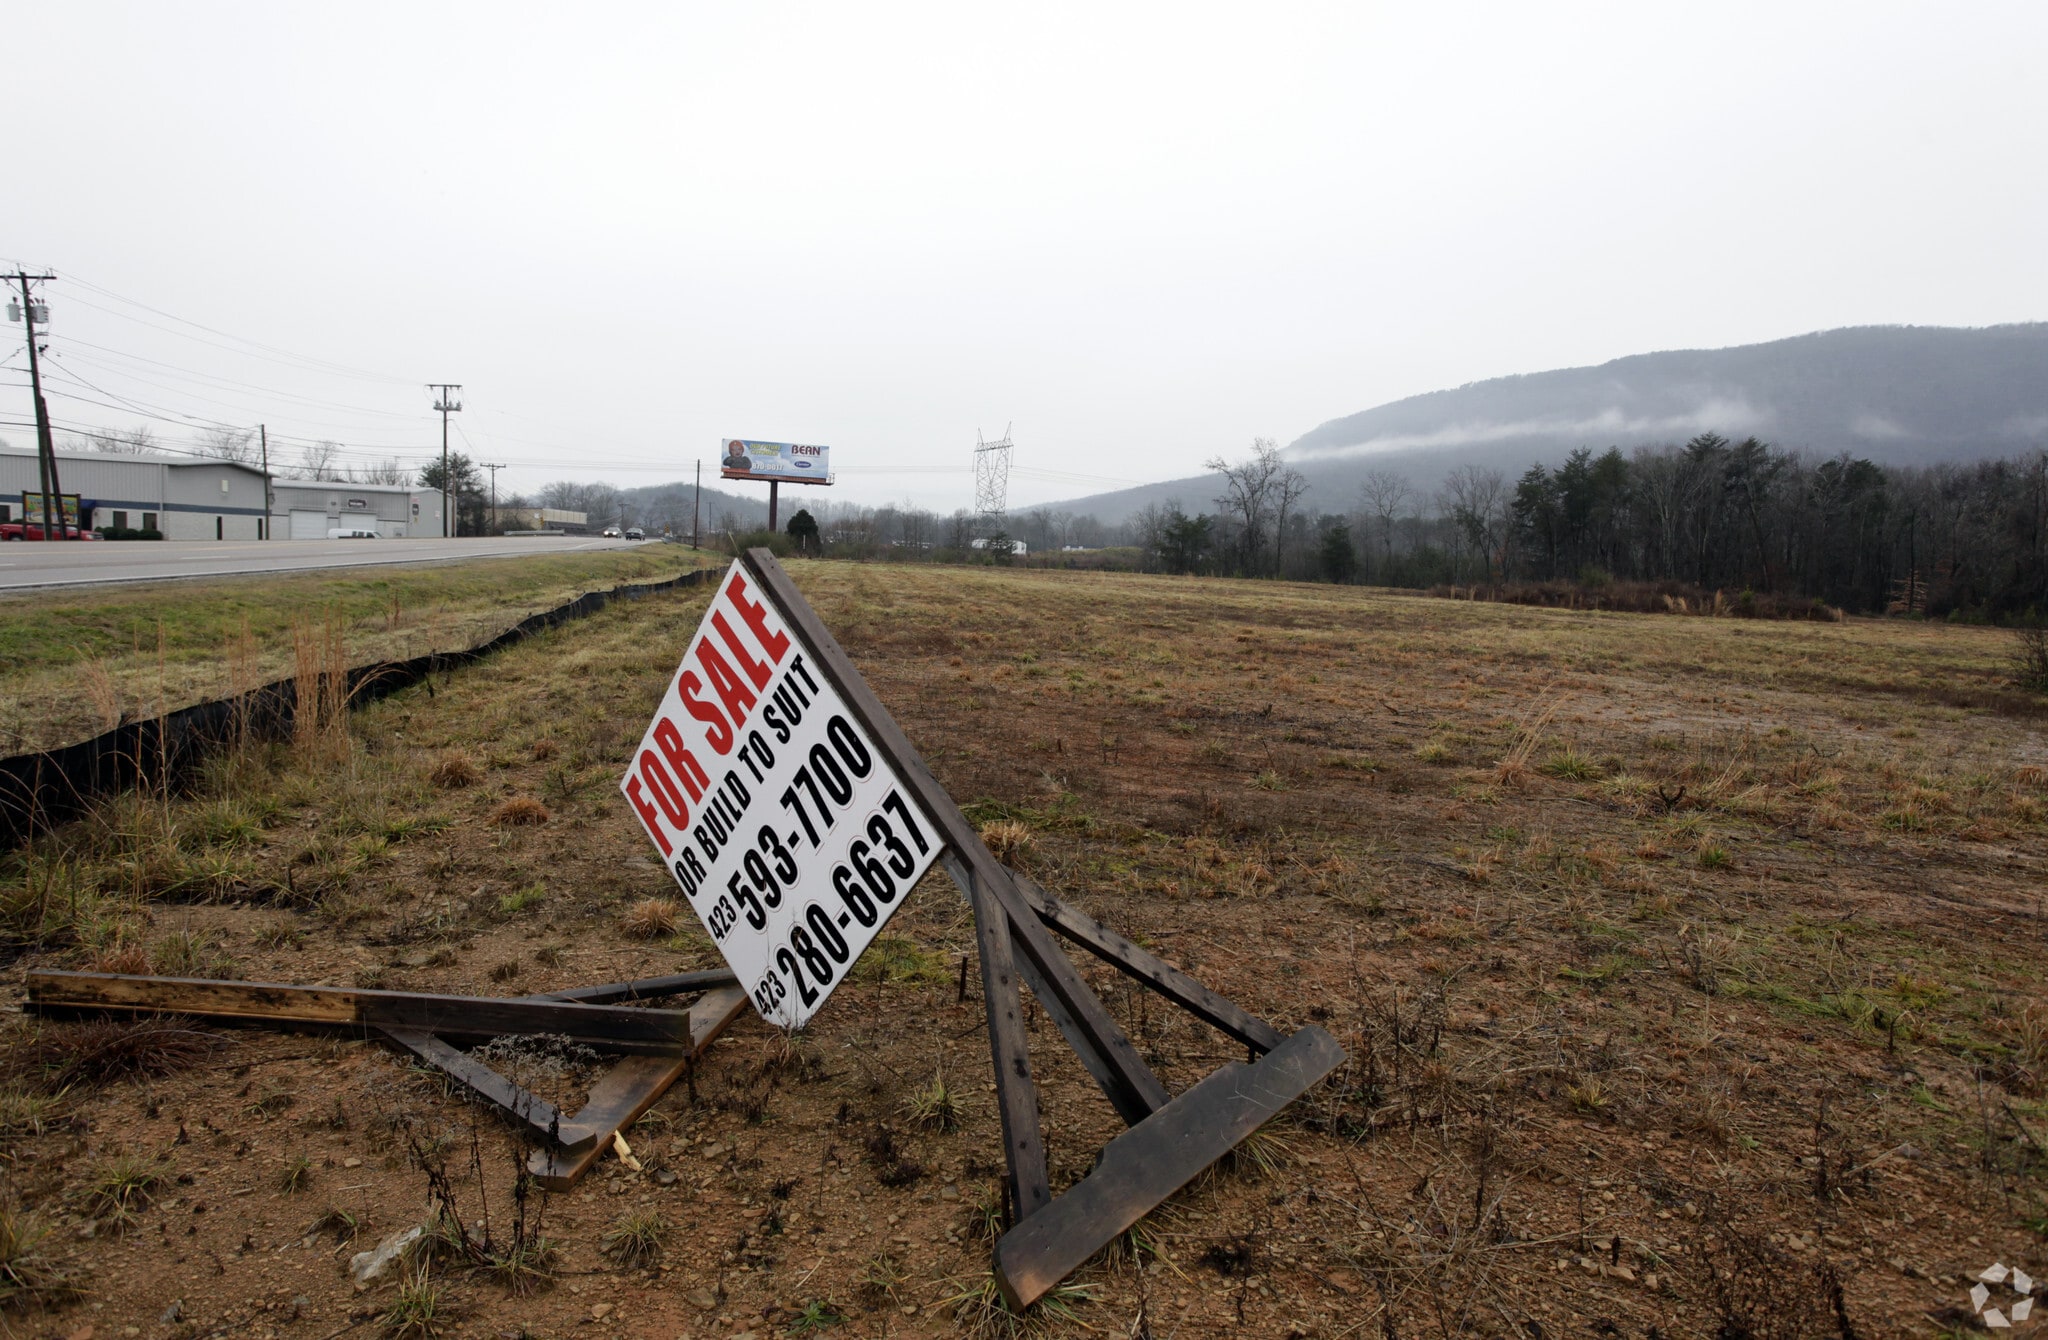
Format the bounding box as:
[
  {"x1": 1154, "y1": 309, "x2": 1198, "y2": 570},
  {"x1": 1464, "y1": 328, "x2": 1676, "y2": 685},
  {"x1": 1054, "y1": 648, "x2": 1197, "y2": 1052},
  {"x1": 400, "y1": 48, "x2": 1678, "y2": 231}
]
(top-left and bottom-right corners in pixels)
[{"x1": 0, "y1": 563, "x2": 2048, "y2": 1340}]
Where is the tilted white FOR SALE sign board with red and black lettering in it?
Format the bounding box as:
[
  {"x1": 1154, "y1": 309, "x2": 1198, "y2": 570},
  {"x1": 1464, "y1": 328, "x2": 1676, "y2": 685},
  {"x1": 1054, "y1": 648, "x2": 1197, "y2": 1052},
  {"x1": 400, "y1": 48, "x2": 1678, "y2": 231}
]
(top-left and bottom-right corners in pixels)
[{"x1": 618, "y1": 563, "x2": 940, "y2": 1029}]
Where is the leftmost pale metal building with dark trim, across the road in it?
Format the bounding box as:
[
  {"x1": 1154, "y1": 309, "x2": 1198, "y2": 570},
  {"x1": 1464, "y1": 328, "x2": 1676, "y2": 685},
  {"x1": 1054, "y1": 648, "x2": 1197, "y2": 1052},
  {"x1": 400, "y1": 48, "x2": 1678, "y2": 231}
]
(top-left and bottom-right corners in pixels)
[{"x1": 0, "y1": 447, "x2": 270, "y2": 539}]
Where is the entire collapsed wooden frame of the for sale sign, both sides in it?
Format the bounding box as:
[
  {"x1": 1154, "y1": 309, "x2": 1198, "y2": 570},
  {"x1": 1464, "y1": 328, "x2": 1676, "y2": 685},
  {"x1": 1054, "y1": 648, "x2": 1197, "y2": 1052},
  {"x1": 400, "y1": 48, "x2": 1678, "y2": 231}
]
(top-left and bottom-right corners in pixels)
[{"x1": 27, "y1": 549, "x2": 1346, "y2": 1309}]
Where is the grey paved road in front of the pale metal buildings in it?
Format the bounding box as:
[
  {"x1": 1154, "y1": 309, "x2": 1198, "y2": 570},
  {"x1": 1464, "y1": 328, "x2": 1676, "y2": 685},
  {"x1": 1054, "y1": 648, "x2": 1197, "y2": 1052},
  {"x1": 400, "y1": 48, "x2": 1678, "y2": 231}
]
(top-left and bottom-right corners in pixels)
[{"x1": 0, "y1": 535, "x2": 649, "y2": 590}]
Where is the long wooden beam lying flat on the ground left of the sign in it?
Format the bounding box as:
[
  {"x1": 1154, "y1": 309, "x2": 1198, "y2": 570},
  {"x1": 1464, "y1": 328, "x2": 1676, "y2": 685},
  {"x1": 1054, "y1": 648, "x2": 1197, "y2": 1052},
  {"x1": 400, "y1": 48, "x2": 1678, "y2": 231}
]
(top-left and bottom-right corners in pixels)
[{"x1": 27, "y1": 971, "x2": 690, "y2": 1053}]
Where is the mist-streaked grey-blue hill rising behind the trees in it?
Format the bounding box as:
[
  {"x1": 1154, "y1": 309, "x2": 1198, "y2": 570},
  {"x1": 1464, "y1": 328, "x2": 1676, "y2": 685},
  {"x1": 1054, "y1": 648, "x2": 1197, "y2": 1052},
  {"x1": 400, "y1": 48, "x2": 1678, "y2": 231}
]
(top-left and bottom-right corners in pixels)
[{"x1": 1051, "y1": 322, "x2": 2048, "y2": 522}]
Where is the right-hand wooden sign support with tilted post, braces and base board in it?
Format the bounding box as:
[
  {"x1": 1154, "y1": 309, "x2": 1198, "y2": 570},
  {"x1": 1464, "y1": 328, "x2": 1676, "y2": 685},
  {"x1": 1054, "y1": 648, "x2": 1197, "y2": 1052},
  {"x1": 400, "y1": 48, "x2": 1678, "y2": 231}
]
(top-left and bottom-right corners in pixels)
[{"x1": 741, "y1": 549, "x2": 1346, "y2": 1309}]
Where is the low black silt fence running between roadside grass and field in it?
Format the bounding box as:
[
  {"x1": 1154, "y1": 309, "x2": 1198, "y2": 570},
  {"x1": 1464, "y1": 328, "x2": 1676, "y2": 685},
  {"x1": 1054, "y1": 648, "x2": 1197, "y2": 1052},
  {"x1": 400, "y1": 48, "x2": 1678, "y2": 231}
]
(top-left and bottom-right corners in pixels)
[{"x1": 0, "y1": 568, "x2": 719, "y2": 850}]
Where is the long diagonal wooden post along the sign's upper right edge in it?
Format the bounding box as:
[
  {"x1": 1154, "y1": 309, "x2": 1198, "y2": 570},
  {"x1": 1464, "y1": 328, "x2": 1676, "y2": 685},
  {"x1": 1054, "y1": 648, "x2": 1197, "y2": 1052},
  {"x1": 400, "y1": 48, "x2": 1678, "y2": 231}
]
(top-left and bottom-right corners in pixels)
[{"x1": 745, "y1": 549, "x2": 1167, "y2": 1121}]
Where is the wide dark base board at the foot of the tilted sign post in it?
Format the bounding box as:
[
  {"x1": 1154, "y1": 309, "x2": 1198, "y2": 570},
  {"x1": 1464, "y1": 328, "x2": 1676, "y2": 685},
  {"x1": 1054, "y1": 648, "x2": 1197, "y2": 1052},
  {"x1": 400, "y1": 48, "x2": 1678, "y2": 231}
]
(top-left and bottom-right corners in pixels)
[{"x1": 995, "y1": 1024, "x2": 1343, "y2": 1309}]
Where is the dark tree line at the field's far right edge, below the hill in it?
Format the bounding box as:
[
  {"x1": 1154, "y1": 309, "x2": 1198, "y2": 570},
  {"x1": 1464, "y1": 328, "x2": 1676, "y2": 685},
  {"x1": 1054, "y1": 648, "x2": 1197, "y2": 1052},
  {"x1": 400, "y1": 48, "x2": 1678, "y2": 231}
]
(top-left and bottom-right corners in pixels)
[{"x1": 1135, "y1": 432, "x2": 2048, "y2": 619}]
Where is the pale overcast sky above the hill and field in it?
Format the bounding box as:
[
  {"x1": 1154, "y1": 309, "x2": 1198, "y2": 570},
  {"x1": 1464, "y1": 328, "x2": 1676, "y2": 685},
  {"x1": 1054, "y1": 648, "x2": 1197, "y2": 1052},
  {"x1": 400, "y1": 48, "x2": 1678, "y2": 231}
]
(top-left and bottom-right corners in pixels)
[{"x1": 0, "y1": 0, "x2": 2048, "y2": 510}]
